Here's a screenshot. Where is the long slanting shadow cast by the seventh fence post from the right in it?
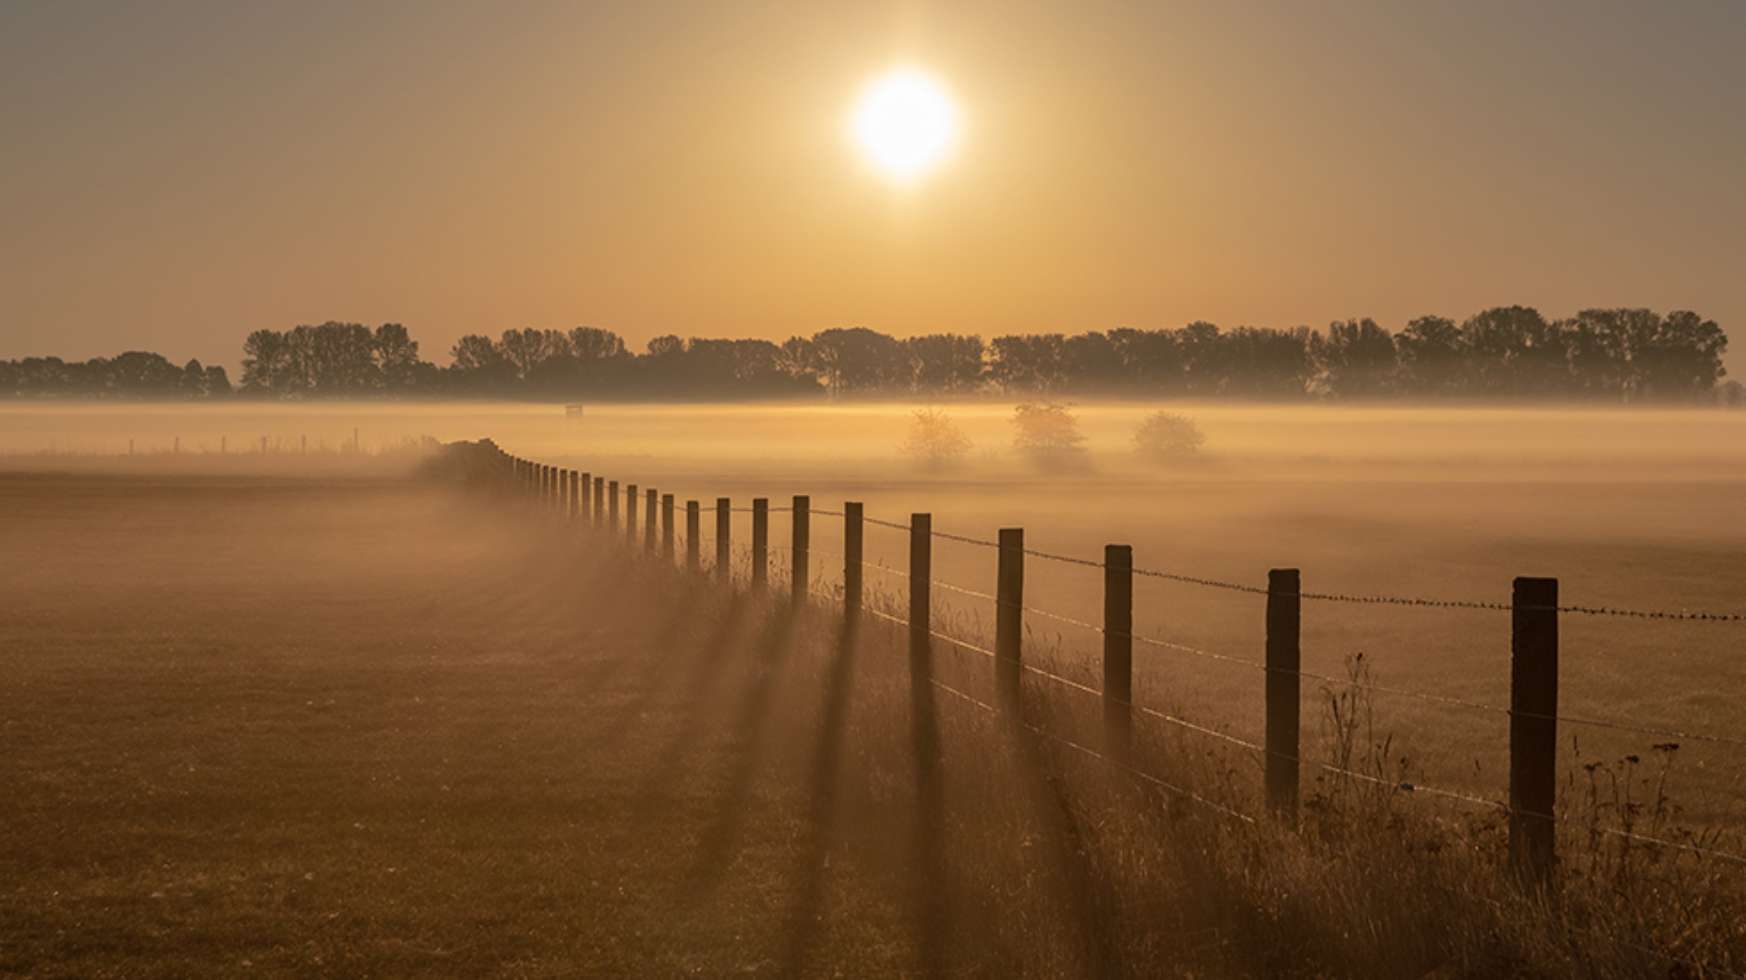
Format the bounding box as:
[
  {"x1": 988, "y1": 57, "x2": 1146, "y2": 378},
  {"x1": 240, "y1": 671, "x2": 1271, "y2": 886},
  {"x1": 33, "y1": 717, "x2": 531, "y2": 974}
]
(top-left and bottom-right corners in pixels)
[{"x1": 690, "y1": 603, "x2": 794, "y2": 894}]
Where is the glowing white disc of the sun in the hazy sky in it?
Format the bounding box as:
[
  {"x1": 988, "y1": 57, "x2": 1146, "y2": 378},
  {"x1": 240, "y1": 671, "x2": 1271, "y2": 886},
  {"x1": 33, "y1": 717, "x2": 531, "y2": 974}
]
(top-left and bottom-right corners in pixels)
[{"x1": 852, "y1": 68, "x2": 959, "y2": 180}]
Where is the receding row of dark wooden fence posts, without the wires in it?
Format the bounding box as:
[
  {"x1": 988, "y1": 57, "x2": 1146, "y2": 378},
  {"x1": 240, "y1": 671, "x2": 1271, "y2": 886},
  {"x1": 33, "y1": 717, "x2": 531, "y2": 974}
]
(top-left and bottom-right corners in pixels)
[{"x1": 499, "y1": 451, "x2": 1559, "y2": 884}]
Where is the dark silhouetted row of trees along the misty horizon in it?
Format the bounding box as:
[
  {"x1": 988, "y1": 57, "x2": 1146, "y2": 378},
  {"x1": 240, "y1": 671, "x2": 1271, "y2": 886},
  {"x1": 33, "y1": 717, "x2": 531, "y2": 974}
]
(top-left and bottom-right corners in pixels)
[{"x1": 0, "y1": 306, "x2": 1746, "y2": 404}]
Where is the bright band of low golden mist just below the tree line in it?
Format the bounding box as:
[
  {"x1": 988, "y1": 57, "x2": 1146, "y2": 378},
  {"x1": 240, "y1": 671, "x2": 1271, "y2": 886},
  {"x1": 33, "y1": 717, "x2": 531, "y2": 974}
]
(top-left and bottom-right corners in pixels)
[{"x1": 0, "y1": 400, "x2": 1746, "y2": 486}]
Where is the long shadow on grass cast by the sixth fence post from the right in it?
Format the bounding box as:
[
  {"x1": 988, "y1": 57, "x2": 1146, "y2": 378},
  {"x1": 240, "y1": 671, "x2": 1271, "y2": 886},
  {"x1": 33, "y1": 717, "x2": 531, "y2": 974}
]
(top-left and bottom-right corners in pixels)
[{"x1": 780, "y1": 618, "x2": 859, "y2": 977}]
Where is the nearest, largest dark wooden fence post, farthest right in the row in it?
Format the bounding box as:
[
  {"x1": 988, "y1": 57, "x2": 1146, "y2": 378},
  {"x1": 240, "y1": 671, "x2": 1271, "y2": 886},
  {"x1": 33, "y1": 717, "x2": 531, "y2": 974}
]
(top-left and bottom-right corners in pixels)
[{"x1": 1510, "y1": 578, "x2": 1557, "y2": 882}]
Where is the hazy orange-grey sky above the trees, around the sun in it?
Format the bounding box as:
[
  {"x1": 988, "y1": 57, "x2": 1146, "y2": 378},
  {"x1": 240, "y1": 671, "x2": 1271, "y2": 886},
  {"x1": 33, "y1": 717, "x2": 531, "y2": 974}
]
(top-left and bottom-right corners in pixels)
[{"x1": 0, "y1": 0, "x2": 1746, "y2": 376}]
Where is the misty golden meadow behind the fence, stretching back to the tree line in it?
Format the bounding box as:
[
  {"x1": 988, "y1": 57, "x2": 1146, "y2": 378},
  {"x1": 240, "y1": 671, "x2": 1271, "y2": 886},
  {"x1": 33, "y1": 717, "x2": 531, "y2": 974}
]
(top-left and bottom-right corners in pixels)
[{"x1": 0, "y1": 402, "x2": 1746, "y2": 826}]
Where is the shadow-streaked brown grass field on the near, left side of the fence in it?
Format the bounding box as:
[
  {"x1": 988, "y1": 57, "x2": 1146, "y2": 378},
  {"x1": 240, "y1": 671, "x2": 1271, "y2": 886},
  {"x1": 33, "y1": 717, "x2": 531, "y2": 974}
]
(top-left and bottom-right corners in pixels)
[{"x1": 0, "y1": 472, "x2": 1746, "y2": 977}]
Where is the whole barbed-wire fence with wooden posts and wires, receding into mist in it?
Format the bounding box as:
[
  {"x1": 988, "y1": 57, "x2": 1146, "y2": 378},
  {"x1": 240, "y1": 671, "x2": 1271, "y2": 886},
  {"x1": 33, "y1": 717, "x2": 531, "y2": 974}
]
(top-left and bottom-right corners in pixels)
[{"x1": 485, "y1": 444, "x2": 1746, "y2": 880}]
